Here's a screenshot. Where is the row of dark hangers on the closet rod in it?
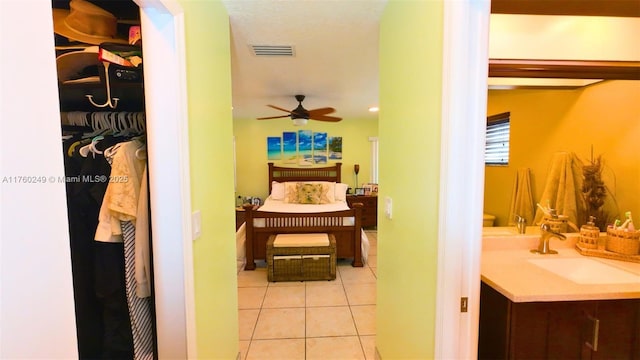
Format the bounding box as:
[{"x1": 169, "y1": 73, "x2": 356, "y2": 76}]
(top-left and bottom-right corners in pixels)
[{"x1": 60, "y1": 111, "x2": 146, "y2": 133}]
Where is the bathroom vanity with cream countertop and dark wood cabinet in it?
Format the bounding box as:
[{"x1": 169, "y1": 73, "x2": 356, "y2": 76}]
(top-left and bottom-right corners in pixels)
[{"x1": 478, "y1": 234, "x2": 640, "y2": 359}]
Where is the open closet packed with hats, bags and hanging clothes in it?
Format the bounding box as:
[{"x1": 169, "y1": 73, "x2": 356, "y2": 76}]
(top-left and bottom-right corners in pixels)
[{"x1": 52, "y1": 0, "x2": 157, "y2": 359}]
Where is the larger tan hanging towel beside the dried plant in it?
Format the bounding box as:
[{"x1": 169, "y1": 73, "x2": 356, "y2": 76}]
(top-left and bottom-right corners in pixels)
[{"x1": 535, "y1": 152, "x2": 586, "y2": 228}]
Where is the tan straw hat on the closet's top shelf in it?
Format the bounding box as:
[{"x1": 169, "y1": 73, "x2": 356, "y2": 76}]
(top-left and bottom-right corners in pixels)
[{"x1": 53, "y1": 0, "x2": 128, "y2": 45}]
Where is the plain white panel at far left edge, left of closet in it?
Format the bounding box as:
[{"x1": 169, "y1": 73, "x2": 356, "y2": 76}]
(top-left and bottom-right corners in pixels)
[{"x1": 0, "y1": 0, "x2": 78, "y2": 359}]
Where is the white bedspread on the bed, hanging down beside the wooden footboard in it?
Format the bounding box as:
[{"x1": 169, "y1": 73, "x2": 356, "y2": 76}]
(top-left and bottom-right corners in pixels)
[{"x1": 236, "y1": 197, "x2": 369, "y2": 272}]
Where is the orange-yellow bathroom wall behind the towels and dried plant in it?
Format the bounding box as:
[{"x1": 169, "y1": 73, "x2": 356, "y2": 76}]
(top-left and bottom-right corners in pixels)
[{"x1": 484, "y1": 81, "x2": 640, "y2": 225}]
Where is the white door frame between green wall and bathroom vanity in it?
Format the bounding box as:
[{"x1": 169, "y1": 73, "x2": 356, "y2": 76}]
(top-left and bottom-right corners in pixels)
[{"x1": 434, "y1": 0, "x2": 491, "y2": 359}]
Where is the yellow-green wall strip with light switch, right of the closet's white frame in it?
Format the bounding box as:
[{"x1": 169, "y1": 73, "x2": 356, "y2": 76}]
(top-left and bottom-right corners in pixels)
[{"x1": 181, "y1": 0, "x2": 238, "y2": 359}]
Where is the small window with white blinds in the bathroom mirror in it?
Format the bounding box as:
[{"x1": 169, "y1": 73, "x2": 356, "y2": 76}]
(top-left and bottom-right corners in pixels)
[{"x1": 484, "y1": 112, "x2": 511, "y2": 165}]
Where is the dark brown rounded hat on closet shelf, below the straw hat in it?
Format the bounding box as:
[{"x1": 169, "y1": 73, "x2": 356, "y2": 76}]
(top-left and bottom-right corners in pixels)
[{"x1": 56, "y1": 46, "x2": 103, "y2": 84}]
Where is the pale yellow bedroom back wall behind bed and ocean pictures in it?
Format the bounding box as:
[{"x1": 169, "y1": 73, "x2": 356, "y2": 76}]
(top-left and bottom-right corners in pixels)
[{"x1": 233, "y1": 116, "x2": 378, "y2": 200}]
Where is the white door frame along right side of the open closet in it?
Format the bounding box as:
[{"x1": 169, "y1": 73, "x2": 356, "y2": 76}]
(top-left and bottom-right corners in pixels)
[{"x1": 134, "y1": 0, "x2": 197, "y2": 359}]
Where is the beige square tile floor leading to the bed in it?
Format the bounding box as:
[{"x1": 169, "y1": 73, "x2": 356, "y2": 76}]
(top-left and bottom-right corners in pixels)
[{"x1": 238, "y1": 230, "x2": 377, "y2": 360}]
